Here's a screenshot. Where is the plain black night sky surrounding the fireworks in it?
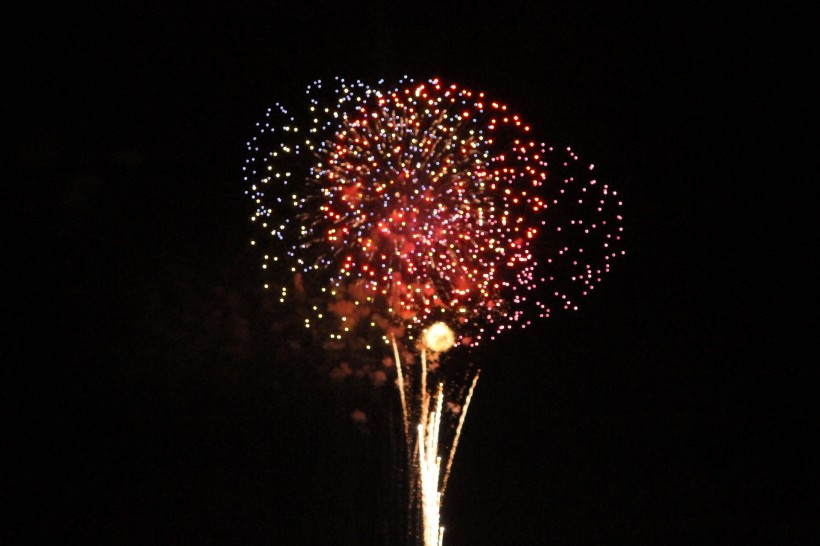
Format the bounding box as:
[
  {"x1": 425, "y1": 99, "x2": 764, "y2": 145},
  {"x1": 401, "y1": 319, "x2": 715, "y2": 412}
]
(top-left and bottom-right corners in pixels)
[{"x1": 8, "y1": 0, "x2": 816, "y2": 545}]
